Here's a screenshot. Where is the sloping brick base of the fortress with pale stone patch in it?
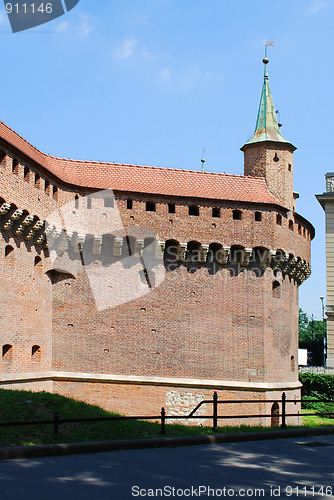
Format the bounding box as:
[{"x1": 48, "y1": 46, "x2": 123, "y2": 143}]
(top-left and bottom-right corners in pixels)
[{"x1": 0, "y1": 375, "x2": 301, "y2": 426}]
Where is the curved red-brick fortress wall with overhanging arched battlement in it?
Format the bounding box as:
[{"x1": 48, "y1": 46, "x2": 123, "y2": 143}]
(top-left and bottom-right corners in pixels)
[{"x1": 0, "y1": 131, "x2": 312, "y2": 424}]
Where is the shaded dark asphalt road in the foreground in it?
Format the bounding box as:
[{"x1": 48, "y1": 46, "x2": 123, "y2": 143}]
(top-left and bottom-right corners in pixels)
[{"x1": 0, "y1": 436, "x2": 334, "y2": 500}]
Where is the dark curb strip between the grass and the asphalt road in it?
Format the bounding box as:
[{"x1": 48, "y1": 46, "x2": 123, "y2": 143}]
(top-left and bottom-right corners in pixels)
[{"x1": 0, "y1": 426, "x2": 334, "y2": 460}]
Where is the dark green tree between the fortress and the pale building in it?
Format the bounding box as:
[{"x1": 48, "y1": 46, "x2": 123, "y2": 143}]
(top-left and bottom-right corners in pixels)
[{"x1": 299, "y1": 309, "x2": 326, "y2": 366}]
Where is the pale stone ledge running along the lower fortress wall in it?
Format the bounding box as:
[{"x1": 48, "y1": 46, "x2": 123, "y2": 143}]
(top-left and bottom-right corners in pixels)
[{"x1": 0, "y1": 371, "x2": 302, "y2": 392}]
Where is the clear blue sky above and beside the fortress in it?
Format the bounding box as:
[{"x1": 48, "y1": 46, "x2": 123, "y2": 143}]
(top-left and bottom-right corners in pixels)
[{"x1": 0, "y1": 0, "x2": 334, "y2": 318}]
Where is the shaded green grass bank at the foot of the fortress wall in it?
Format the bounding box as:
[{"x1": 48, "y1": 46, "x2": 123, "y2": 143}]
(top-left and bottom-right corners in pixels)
[{"x1": 0, "y1": 389, "x2": 334, "y2": 446}]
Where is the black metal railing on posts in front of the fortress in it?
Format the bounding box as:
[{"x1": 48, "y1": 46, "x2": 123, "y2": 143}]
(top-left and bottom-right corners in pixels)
[{"x1": 0, "y1": 392, "x2": 334, "y2": 436}]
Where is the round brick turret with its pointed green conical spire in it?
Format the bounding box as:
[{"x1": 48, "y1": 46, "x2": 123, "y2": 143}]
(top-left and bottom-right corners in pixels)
[{"x1": 241, "y1": 58, "x2": 296, "y2": 210}]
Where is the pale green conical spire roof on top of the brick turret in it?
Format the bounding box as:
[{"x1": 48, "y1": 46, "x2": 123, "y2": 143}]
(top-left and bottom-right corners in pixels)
[{"x1": 241, "y1": 58, "x2": 294, "y2": 149}]
